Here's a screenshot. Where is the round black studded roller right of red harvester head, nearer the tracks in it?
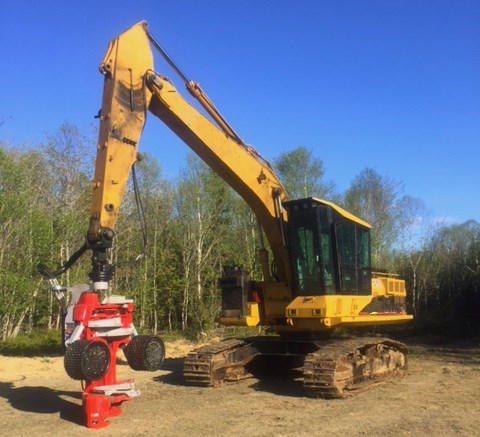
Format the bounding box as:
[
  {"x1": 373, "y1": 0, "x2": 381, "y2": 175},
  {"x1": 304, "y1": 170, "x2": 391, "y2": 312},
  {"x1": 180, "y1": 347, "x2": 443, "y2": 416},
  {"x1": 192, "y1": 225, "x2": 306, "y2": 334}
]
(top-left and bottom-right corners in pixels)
[{"x1": 123, "y1": 335, "x2": 165, "y2": 371}]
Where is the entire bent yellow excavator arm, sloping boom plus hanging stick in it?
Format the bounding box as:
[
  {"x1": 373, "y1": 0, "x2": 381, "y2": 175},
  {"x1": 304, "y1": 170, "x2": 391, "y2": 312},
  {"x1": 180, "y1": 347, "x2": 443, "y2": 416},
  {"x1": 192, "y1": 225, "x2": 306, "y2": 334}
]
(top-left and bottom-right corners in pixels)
[{"x1": 88, "y1": 22, "x2": 290, "y2": 282}]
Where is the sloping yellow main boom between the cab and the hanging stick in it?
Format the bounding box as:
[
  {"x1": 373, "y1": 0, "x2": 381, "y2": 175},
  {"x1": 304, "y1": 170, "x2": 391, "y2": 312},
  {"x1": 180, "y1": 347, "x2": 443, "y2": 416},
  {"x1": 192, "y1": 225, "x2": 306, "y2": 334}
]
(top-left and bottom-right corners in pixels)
[{"x1": 147, "y1": 73, "x2": 290, "y2": 282}]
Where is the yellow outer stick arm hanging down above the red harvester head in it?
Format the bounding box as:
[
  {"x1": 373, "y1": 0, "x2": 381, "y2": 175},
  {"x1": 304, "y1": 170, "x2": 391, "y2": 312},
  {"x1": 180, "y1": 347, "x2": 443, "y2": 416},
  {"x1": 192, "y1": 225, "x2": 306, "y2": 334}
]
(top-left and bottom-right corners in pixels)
[{"x1": 88, "y1": 21, "x2": 153, "y2": 242}]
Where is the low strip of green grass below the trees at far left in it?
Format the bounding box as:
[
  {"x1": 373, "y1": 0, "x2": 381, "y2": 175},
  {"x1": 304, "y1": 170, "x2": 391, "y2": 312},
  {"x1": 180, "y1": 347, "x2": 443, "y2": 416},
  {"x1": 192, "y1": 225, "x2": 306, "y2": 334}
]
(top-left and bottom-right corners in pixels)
[{"x1": 0, "y1": 330, "x2": 63, "y2": 357}]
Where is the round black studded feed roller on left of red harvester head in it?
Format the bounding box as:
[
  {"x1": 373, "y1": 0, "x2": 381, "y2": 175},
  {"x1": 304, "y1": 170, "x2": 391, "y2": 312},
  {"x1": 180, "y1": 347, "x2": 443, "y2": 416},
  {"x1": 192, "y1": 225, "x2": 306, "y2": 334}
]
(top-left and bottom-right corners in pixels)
[{"x1": 63, "y1": 340, "x2": 110, "y2": 381}]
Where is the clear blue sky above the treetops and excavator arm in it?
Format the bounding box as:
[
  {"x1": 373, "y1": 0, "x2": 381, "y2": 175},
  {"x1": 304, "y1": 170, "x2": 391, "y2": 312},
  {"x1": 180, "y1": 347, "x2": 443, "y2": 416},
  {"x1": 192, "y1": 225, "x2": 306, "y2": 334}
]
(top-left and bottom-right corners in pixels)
[{"x1": 0, "y1": 0, "x2": 480, "y2": 224}]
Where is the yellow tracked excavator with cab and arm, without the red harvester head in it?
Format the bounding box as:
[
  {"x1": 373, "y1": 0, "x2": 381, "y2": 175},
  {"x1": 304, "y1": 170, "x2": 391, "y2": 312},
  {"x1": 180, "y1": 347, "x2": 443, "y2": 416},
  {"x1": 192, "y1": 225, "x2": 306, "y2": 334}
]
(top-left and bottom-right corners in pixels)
[{"x1": 53, "y1": 22, "x2": 412, "y2": 397}]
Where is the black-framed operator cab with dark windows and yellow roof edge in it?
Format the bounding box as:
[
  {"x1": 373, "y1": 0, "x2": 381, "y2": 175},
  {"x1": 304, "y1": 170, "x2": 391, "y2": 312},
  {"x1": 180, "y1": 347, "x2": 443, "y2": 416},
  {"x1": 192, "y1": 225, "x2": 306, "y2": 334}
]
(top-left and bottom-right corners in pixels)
[{"x1": 283, "y1": 197, "x2": 371, "y2": 296}]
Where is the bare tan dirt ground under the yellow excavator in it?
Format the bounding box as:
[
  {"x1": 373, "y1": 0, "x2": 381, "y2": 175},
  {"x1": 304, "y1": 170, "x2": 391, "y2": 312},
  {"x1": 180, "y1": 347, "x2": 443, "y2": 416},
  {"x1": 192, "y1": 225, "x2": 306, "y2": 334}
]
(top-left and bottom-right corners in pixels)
[{"x1": 0, "y1": 341, "x2": 480, "y2": 437}]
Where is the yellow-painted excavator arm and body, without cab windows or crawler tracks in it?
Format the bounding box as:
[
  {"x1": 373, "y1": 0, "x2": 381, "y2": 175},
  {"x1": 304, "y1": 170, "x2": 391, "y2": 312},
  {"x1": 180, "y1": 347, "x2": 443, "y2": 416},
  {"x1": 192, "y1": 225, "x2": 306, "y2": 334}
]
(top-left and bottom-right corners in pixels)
[{"x1": 88, "y1": 22, "x2": 412, "y2": 331}]
